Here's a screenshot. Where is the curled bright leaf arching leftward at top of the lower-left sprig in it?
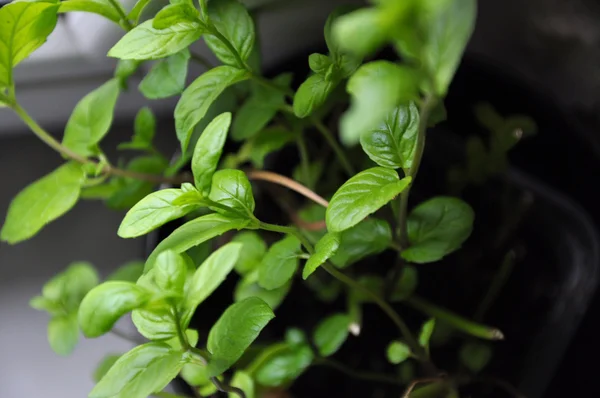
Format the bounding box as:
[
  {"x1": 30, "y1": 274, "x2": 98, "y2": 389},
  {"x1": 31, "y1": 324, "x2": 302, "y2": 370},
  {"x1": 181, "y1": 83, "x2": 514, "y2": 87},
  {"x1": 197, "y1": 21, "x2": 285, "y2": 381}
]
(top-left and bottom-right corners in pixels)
[{"x1": 79, "y1": 281, "x2": 151, "y2": 337}]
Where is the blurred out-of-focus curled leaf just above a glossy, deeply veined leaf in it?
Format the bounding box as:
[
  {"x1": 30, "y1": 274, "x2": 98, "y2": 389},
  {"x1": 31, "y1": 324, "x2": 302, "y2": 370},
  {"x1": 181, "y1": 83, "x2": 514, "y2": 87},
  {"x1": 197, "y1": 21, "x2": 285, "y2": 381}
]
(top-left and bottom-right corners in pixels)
[{"x1": 340, "y1": 61, "x2": 420, "y2": 145}]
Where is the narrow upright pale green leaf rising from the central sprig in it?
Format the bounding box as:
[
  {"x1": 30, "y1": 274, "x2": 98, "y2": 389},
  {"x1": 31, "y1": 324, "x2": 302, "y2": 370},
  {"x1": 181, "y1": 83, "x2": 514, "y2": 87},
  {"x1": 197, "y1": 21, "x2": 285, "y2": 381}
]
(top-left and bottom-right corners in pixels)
[{"x1": 192, "y1": 112, "x2": 231, "y2": 196}]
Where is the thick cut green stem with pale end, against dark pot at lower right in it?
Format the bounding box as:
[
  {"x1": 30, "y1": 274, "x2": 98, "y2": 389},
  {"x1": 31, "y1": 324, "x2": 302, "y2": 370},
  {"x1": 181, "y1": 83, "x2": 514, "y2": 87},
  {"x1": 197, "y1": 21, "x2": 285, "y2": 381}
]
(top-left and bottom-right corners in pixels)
[{"x1": 404, "y1": 295, "x2": 504, "y2": 340}]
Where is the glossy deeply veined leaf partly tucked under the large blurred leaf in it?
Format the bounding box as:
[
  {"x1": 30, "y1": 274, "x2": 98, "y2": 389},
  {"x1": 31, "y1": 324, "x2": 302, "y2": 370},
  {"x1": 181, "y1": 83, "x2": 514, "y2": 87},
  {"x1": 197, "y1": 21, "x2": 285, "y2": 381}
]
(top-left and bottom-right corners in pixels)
[{"x1": 360, "y1": 102, "x2": 419, "y2": 170}]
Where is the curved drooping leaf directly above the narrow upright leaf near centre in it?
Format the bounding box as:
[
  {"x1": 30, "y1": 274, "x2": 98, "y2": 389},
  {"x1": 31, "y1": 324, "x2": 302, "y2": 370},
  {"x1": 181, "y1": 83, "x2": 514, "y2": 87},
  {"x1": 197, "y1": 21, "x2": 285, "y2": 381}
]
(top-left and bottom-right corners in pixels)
[{"x1": 175, "y1": 65, "x2": 249, "y2": 152}]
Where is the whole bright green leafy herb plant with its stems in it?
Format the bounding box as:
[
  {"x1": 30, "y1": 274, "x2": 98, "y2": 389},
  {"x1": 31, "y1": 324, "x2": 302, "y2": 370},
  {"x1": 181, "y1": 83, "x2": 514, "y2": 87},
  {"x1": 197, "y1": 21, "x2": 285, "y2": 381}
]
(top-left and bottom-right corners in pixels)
[{"x1": 0, "y1": 0, "x2": 524, "y2": 398}]
